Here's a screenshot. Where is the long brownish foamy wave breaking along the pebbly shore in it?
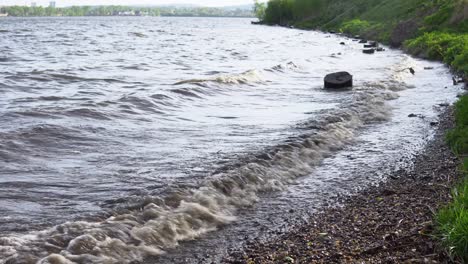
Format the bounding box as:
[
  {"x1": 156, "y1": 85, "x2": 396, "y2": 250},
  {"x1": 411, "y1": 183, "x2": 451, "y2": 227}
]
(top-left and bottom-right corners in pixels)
[{"x1": 0, "y1": 77, "x2": 414, "y2": 264}]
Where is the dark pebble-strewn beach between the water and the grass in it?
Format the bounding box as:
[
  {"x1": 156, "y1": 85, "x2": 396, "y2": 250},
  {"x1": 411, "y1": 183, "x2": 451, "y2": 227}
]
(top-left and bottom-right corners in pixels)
[{"x1": 224, "y1": 108, "x2": 460, "y2": 263}]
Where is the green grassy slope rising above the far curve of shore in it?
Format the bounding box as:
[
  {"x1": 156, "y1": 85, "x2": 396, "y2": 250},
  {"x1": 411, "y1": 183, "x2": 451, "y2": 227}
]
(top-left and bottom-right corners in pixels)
[{"x1": 255, "y1": 0, "x2": 468, "y2": 81}]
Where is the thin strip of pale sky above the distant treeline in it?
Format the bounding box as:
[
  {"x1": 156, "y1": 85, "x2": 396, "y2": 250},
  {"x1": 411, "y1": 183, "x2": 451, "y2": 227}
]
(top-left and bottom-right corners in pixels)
[{"x1": 0, "y1": 0, "x2": 264, "y2": 7}]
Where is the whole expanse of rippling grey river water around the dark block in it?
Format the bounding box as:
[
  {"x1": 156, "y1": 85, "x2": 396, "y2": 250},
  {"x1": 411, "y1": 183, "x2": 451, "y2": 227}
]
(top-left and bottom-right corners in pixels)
[{"x1": 0, "y1": 17, "x2": 460, "y2": 263}]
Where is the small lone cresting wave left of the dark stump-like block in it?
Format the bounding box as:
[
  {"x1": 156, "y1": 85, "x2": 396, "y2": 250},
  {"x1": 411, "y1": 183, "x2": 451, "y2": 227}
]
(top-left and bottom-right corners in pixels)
[{"x1": 174, "y1": 70, "x2": 262, "y2": 85}]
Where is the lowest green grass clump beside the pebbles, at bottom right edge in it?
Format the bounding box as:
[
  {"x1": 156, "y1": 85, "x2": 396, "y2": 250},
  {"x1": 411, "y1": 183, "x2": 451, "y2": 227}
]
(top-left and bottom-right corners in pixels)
[{"x1": 436, "y1": 178, "x2": 468, "y2": 262}]
